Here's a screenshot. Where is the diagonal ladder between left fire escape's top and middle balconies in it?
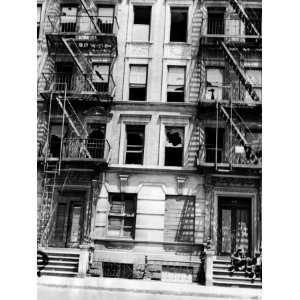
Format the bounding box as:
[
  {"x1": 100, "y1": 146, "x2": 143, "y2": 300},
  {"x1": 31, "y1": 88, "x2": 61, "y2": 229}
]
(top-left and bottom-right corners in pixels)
[{"x1": 62, "y1": 38, "x2": 97, "y2": 92}]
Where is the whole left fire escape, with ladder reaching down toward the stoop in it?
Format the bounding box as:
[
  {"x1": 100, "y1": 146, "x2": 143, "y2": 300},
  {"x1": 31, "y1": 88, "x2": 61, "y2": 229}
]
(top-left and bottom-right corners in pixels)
[{"x1": 38, "y1": 0, "x2": 118, "y2": 246}]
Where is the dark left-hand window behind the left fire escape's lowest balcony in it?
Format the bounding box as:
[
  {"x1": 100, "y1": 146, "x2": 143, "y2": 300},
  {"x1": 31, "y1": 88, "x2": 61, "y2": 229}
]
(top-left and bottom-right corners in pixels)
[{"x1": 49, "y1": 123, "x2": 67, "y2": 158}]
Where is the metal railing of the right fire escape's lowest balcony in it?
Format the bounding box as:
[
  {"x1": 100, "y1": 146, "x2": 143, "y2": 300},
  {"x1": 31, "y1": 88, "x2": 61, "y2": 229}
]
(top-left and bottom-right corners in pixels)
[{"x1": 198, "y1": 143, "x2": 262, "y2": 165}]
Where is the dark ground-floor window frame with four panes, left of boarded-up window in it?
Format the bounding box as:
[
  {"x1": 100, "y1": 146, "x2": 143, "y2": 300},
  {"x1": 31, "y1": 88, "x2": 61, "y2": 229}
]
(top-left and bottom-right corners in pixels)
[{"x1": 106, "y1": 193, "x2": 137, "y2": 240}]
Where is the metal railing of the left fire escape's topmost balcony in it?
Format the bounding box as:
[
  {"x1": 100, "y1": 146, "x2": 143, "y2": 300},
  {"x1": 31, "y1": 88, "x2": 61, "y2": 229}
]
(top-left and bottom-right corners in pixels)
[{"x1": 48, "y1": 15, "x2": 119, "y2": 36}]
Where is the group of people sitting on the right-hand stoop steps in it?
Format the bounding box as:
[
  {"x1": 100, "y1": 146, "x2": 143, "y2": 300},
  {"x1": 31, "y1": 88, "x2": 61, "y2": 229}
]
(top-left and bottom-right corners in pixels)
[{"x1": 229, "y1": 248, "x2": 262, "y2": 282}]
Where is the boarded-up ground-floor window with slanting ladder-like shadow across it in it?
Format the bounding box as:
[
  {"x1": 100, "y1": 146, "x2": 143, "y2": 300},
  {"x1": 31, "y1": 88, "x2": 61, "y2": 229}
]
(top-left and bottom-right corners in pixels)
[{"x1": 164, "y1": 196, "x2": 195, "y2": 243}]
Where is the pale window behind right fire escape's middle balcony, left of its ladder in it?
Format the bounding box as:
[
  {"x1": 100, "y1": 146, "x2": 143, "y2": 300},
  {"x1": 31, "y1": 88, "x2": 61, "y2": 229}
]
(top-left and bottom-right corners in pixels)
[{"x1": 205, "y1": 68, "x2": 223, "y2": 100}]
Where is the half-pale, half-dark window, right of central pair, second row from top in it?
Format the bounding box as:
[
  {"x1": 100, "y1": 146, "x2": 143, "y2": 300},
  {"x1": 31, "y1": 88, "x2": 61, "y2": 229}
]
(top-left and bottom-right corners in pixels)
[{"x1": 167, "y1": 66, "x2": 185, "y2": 102}]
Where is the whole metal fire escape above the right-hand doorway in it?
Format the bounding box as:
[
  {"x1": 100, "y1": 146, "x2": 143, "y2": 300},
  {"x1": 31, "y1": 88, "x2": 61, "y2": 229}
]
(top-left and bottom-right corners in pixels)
[{"x1": 197, "y1": 0, "x2": 262, "y2": 172}]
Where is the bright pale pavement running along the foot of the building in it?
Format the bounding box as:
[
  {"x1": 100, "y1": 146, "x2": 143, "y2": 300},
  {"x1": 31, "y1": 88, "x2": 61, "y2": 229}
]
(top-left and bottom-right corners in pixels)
[{"x1": 38, "y1": 276, "x2": 261, "y2": 300}]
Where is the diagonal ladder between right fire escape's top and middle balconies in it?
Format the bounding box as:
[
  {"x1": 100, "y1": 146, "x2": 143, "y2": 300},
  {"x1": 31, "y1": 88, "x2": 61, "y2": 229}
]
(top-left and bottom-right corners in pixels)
[{"x1": 219, "y1": 41, "x2": 260, "y2": 101}]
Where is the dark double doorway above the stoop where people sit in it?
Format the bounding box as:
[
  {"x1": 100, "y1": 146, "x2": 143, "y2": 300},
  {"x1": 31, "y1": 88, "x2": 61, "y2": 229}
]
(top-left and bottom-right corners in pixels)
[{"x1": 217, "y1": 197, "x2": 251, "y2": 256}]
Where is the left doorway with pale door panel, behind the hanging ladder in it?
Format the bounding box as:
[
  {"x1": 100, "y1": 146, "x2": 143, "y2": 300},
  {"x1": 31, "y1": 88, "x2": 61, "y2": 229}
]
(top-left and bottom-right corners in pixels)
[{"x1": 50, "y1": 192, "x2": 86, "y2": 248}]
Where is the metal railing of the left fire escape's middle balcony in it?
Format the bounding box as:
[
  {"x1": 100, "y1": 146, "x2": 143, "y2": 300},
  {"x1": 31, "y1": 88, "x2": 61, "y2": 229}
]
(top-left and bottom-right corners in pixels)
[{"x1": 42, "y1": 73, "x2": 116, "y2": 96}]
